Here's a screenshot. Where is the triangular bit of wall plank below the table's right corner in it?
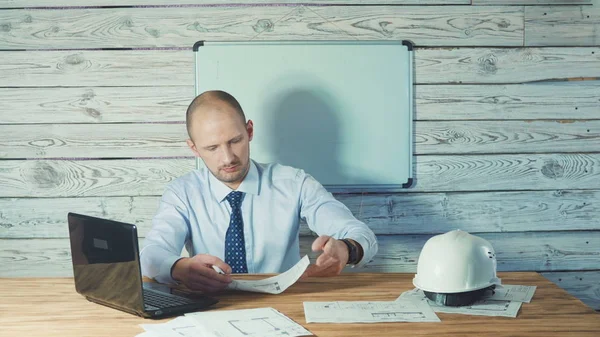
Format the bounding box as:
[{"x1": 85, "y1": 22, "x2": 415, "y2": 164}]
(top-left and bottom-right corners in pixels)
[{"x1": 542, "y1": 271, "x2": 600, "y2": 310}]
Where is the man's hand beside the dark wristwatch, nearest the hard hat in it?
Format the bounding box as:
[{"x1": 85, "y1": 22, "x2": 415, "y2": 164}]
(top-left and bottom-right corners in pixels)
[{"x1": 303, "y1": 235, "x2": 348, "y2": 277}]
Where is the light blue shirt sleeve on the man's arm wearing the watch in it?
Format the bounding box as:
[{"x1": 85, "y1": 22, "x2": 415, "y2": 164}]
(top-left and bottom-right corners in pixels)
[{"x1": 298, "y1": 171, "x2": 379, "y2": 267}]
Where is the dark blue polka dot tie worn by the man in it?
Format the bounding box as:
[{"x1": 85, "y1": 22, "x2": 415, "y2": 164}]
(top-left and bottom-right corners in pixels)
[{"x1": 225, "y1": 191, "x2": 248, "y2": 274}]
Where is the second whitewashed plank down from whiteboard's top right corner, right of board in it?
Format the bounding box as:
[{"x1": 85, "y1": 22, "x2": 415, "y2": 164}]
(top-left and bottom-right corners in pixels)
[{"x1": 414, "y1": 81, "x2": 600, "y2": 121}]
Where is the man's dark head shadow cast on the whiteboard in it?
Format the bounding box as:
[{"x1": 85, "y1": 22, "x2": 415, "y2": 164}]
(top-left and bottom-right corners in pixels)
[{"x1": 251, "y1": 88, "x2": 375, "y2": 191}]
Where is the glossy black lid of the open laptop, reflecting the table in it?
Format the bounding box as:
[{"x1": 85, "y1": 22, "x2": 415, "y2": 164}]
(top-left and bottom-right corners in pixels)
[{"x1": 68, "y1": 213, "x2": 144, "y2": 312}]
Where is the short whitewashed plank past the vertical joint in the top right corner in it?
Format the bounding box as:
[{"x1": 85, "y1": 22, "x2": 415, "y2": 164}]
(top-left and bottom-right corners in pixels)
[{"x1": 525, "y1": 3, "x2": 600, "y2": 46}]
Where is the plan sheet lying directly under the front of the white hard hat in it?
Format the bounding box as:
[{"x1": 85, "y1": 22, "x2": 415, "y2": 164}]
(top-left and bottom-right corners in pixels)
[{"x1": 396, "y1": 289, "x2": 521, "y2": 318}]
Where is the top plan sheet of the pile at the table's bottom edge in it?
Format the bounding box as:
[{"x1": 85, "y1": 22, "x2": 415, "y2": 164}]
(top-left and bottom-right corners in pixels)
[{"x1": 185, "y1": 308, "x2": 312, "y2": 337}]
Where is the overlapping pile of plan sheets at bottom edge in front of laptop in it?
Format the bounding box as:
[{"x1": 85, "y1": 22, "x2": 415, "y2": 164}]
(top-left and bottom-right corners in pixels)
[{"x1": 137, "y1": 308, "x2": 312, "y2": 337}]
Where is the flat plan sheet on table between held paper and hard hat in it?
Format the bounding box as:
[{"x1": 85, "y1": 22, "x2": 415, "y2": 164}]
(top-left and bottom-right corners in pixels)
[{"x1": 304, "y1": 299, "x2": 440, "y2": 323}]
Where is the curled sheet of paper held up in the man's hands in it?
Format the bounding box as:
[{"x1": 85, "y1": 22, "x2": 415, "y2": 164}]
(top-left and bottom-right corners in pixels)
[{"x1": 228, "y1": 255, "x2": 310, "y2": 294}]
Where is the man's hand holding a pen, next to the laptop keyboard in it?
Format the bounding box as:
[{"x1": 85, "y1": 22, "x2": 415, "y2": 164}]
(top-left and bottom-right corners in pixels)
[{"x1": 171, "y1": 254, "x2": 232, "y2": 293}]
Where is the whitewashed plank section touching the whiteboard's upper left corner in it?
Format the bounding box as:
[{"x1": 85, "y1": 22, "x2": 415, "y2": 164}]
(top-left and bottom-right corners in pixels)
[{"x1": 0, "y1": 49, "x2": 194, "y2": 87}]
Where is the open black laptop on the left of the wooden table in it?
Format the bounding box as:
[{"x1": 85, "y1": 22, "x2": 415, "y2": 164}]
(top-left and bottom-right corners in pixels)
[{"x1": 67, "y1": 213, "x2": 218, "y2": 318}]
